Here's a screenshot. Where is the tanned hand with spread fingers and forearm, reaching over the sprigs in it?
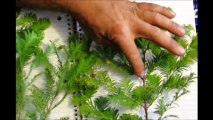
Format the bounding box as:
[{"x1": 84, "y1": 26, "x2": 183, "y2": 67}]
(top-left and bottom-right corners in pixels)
[{"x1": 17, "y1": 0, "x2": 185, "y2": 77}]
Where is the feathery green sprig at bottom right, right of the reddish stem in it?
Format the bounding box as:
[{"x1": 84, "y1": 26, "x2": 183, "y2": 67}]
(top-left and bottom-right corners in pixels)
[{"x1": 152, "y1": 73, "x2": 195, "y2": 120}]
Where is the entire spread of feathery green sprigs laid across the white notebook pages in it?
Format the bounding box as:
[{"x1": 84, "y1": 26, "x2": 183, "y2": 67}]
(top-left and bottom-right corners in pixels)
[{"x1": 16, "y1": 11, "x2": 197, "y2": 120}]
